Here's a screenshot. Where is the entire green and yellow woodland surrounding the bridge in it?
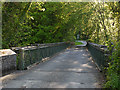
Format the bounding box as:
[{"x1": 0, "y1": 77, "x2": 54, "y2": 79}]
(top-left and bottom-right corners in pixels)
[{"x1": 2, "y1": 2, "x2": 120, "y2": 89}]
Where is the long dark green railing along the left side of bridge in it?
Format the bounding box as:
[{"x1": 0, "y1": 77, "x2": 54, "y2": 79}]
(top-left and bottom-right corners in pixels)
[{"x1": 12, "y1": 42, "x2": 70, "y2": 70}]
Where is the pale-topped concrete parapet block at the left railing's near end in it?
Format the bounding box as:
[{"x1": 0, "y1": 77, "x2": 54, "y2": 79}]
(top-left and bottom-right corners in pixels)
[{"x1": 0, "y1": 49, "x2": 16, "y2": 76}]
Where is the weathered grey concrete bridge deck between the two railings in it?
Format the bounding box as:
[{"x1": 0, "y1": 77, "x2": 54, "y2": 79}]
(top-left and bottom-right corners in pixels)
[{"x1": 3, "y1": 48, "x2": 102, "y2": 88}]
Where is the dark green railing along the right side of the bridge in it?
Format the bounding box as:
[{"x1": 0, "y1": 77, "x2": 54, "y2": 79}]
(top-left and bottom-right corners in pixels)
[{"x1": 87, "y1": 43, "x2": 109, "y2": 71}]
